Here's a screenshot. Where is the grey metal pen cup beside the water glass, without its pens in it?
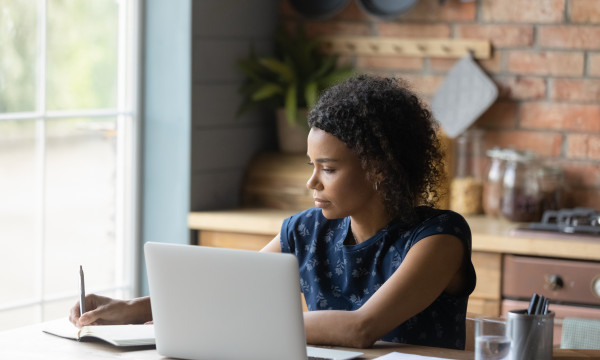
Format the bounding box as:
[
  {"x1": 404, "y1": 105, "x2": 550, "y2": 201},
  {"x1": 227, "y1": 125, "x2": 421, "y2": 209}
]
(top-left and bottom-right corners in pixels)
[{"x1": 507, "y1": 310, "x2": 554, "y2": 360}]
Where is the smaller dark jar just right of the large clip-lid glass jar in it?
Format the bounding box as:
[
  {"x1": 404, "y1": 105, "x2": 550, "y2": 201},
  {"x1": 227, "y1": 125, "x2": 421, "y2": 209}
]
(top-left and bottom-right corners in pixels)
[{"x1": 538, "y1": 166, "x2": 566, "y2": 214}]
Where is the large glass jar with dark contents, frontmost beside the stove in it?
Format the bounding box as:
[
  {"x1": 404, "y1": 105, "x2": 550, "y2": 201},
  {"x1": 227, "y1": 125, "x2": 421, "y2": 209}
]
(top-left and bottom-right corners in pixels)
[{"x1": 501, "y1": 151, "x2": 541, "y2": 222}]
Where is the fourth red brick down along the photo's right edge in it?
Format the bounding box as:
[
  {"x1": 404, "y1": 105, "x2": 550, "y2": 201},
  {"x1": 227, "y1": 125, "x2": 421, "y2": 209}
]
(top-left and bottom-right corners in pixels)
[{"x1": 550, "y1": 79, "x2": 600, "y2": 101}]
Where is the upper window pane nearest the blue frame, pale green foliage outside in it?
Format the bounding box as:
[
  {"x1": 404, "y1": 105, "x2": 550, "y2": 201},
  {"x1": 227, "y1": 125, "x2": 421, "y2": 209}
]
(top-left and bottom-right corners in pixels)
[{"x1": 46, "y1": 0, "x2": 118, "y2": 110}]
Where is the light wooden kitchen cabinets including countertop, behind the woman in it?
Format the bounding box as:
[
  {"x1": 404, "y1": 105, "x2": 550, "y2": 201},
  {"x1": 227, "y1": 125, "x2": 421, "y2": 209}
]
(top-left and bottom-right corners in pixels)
[{"x1": 188, "y1": 209, "x2": 600, "y2": 344}]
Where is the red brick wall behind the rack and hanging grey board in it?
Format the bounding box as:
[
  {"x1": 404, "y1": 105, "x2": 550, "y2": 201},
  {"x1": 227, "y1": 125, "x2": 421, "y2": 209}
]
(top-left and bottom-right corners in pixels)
[{"x1": 280, "y1": 0, "x2": 600, "y2": 209}]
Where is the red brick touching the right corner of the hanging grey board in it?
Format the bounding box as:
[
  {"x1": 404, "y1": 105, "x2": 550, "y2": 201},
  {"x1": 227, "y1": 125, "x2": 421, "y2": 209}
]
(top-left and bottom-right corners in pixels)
[{"x1": 495, "y1": 76, "x2": 546, "y2": 100}]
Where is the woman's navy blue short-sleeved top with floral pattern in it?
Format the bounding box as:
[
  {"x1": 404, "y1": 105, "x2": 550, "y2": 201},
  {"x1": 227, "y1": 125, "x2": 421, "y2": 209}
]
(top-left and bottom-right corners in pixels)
[{"x1": 281, "y1": 207, "x2": 475, "y2": 349}]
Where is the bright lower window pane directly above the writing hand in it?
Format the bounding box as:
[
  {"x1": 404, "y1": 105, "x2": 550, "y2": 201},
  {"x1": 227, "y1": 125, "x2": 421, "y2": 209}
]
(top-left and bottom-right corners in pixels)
[{"x1": 43, "y1": 118, "x2": 117, "y2": 296}]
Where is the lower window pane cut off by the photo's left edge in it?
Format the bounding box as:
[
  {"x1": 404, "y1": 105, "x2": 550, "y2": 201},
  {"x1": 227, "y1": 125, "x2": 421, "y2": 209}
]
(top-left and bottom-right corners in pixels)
[{"x1": 0, "y1": 121, "x2": 39, "y2": 305}]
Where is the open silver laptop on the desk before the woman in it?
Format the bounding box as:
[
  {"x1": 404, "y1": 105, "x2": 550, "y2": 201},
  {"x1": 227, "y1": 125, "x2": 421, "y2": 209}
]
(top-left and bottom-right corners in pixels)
[{"x1": 144, "y1": 243, "x2": 362, "y2": 360}]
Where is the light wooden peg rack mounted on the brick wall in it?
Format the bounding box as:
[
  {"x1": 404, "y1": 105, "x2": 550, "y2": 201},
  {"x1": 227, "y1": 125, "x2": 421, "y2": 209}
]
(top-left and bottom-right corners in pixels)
[{"x1": 319, "y1": 36, "x2": 492, "y2": 59}]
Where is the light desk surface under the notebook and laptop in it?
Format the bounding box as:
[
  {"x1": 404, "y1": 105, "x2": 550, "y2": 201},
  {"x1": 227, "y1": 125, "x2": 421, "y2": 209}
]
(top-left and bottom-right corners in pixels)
[{"x1": 0, "y1": 324, "x2": 600, "y2": 360}]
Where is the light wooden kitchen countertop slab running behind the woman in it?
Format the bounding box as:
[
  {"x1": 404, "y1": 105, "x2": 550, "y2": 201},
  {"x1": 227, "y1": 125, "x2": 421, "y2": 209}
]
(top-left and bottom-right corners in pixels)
[{"x1": 188, "y1": 209, "x2": 600, "y2": 261}]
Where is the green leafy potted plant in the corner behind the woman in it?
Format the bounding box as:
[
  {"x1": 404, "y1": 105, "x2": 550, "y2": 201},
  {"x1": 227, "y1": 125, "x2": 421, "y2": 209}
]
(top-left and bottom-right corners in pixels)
[{"x1": 237, "y1": 28, "x2": 353, "y2": 152}]
